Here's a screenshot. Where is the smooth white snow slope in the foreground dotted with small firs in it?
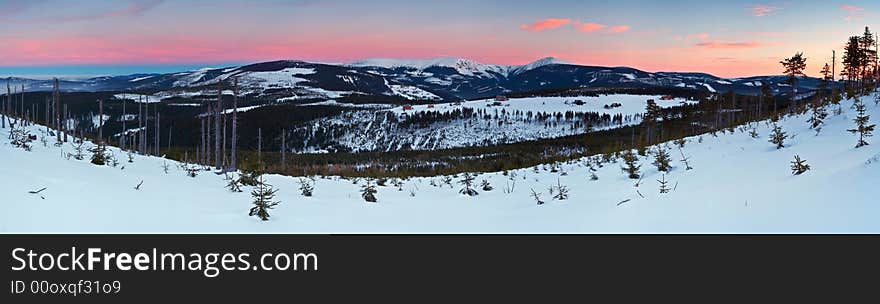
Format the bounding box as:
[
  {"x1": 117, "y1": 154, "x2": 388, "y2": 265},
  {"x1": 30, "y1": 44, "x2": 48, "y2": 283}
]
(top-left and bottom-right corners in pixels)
[{"x1": 0, "y1": 96, "x2": 880, "y2": 233}]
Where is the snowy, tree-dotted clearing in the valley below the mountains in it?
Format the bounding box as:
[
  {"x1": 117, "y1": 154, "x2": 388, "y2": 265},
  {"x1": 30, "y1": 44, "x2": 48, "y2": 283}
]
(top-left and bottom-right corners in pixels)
[{"x1": 293, "y1": 94, "x2": 696, "y2": 151}]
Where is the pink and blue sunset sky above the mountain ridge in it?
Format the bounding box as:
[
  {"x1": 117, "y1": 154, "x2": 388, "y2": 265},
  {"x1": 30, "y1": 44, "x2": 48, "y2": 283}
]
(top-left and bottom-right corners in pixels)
[{"x1": 0, "y1": 0, "x2": 880, "y2": 77}]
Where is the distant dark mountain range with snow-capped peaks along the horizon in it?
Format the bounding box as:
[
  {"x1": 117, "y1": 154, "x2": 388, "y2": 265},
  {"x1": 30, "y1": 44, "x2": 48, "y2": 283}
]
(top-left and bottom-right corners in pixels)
[{"x1": 0, "y1": 57, "x2": 819, "y2": 101}]
